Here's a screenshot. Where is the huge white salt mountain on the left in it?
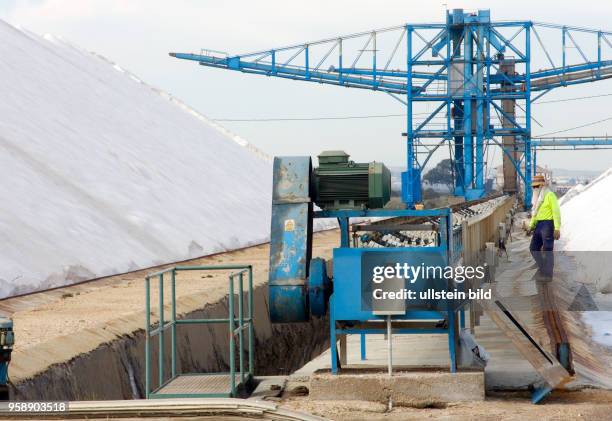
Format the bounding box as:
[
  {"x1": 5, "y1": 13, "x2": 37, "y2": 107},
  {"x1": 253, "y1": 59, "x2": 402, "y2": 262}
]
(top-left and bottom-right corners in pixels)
[{"x1": 0, "y1": 21, "x2": 271, "y2": 296}]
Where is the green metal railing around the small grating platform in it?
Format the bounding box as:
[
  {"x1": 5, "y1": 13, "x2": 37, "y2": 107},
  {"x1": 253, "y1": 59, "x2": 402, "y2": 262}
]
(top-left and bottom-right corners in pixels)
[{"x1": 145, "y1": 265, "x2": 254, "y2": 399}]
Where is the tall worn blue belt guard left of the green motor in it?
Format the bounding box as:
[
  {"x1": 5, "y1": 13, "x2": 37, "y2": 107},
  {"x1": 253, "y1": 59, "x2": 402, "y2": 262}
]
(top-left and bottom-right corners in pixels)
[{"x1": 268, "y1": 157, "x2": 312, "y2": 323}]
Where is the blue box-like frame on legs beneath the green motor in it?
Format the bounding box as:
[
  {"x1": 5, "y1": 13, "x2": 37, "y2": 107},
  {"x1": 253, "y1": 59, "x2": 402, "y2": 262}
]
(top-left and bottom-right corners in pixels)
[{"x1": 315, "y1": 209, "x2": 467, "y2": 373}]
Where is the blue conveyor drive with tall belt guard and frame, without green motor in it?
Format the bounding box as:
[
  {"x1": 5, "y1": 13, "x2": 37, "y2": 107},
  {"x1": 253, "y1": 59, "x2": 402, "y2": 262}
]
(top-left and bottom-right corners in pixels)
[{"x1": 269, "y1": 157, "x2": 465, "y2": 373}]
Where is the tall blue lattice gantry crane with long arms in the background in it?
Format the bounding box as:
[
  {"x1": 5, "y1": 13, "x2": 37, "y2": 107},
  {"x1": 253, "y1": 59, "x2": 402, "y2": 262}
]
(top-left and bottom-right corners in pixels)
[{"x1": 170, "y1": 9, "x2": 612, "y2": 209}]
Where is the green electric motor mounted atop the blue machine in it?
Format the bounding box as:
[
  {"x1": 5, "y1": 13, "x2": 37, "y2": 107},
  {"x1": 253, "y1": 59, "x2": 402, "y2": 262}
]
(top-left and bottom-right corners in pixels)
[{"x1": 313, "y1": 151, "x2": 391, "y2": 210}]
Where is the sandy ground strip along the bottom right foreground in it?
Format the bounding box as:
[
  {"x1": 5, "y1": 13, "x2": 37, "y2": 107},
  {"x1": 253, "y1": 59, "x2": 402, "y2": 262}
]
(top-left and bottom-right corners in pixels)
[{"x1": 282, "y1": 389, "x2": 612, "y2": 421}]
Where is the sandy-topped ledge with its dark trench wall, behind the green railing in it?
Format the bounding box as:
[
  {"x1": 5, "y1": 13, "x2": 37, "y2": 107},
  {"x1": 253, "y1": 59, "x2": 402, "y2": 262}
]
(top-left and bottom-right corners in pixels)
[{"x1": 0, "y1": 230, "x2": 338, "y2": 401}]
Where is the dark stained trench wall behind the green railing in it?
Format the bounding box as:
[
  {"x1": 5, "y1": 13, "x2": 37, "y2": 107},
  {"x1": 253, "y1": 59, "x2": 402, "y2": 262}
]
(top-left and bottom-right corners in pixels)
[{"x1": 11, "y1": 286, "x2": 329, "y2": 400}]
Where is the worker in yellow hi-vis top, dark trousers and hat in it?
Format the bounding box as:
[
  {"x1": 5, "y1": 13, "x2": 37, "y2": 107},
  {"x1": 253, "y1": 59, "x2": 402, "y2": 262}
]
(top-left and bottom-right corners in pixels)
[{"x1": 527, "y1": 174, "x2": 561, "y2": 280}]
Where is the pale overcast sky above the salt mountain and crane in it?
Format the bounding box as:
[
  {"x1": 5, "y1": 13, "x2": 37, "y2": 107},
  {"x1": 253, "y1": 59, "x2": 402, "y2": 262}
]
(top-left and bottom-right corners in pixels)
[{"x1": 0, "y1": 0, "x2": 612, "y2": 170}]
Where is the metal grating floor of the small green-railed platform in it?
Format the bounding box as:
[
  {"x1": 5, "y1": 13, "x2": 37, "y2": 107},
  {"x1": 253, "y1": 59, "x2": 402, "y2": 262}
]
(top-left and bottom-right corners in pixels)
[{"x1": 151, "y1": 373, "x2": 240, "y2": 398}]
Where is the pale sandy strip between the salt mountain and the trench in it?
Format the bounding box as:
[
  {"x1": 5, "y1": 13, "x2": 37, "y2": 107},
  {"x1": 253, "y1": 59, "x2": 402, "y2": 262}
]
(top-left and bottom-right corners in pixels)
[{"x1": 0, "y1": 230, "x2": 339, "y2": 380}]
